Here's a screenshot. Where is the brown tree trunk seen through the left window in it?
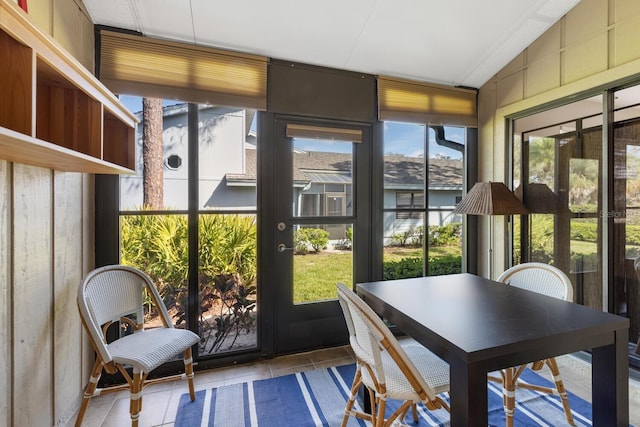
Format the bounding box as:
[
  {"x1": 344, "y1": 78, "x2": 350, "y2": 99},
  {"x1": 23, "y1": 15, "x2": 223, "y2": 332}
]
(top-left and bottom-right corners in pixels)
[{"x1": 142, "y1": 98, "x2": 164, "y2": 209}]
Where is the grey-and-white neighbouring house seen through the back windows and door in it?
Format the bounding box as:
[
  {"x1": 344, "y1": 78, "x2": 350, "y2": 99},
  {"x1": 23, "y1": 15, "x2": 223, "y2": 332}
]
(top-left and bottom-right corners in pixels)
[{"x1": 121, "y1": 104, "x2": 462, "y2": 239}]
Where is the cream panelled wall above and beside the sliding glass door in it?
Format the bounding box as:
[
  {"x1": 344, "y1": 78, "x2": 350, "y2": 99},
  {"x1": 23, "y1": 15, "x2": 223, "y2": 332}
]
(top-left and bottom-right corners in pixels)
[{"x1": 478, "y1": 0, "x2": 640, "y2": 275}]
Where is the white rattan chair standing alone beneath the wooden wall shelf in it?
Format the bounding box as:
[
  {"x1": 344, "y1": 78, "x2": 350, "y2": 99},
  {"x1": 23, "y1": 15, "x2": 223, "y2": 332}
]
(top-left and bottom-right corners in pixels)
[{"x1": 76, "y1": 265, "x2": 199, "y2": 426}]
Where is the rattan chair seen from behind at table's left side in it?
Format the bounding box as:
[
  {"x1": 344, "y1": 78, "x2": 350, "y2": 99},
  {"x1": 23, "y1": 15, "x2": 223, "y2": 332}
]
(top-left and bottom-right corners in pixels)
[{"x1": 338, "y1": 283, "x2": 449, "y2": 427}]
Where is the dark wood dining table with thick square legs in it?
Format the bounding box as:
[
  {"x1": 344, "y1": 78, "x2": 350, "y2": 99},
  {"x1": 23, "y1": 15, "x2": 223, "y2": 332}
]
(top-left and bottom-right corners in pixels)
[{"x1": 356, "y1": 273, "x2": 629, "y2": 427}]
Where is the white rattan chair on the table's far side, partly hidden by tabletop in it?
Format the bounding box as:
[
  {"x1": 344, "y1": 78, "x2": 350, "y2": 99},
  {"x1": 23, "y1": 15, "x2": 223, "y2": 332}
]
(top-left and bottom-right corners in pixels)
[{"x1": 489, "y1": 262, "x2": 574, "y2": 427}]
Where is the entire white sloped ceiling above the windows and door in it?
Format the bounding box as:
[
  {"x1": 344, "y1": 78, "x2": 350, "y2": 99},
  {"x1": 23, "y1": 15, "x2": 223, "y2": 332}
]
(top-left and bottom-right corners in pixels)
[{"x1": 83, "y1": 0, "x2": 580, "y2": 88}]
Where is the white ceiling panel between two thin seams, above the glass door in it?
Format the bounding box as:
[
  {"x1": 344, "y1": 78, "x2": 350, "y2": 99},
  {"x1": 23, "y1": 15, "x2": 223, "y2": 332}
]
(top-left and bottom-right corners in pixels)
[{"x1": 192, "y1": 0, "x2": 375, "y2": 68}]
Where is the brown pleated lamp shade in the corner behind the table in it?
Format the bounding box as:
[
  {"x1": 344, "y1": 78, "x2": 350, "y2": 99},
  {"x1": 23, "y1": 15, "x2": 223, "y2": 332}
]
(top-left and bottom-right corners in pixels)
[{"x1": 453, "y1": 182, "x2": 529, "y2": 215}]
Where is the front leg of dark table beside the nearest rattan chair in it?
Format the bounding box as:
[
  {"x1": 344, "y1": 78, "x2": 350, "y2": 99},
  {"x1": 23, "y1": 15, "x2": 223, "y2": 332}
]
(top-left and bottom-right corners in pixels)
[{"x1": 449, "y1": 362, "x2": 489, "y2": 427}]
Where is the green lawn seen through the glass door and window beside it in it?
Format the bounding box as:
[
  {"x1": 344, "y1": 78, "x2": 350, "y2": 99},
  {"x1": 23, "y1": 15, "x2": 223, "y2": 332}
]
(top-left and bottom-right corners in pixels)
[{"x1": 293, "y1": 246, "x2": 460, "y2": 304}]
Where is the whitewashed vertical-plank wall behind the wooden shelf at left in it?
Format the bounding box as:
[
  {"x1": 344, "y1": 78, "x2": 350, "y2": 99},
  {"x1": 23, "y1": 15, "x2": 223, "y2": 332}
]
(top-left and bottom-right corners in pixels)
[{"x1": 0, "y1": 0, "x2": 94, "y2": 427}]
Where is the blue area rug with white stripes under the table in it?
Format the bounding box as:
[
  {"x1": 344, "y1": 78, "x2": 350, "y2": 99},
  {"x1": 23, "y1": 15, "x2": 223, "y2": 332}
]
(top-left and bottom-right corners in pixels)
[{"x1": 175, "y1": 364, "x2": 608, "y2": 427}]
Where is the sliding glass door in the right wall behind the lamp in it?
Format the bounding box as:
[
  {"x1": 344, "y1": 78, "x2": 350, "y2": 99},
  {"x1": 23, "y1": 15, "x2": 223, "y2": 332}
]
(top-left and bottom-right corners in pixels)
[{"x1": 513, "y1": 86, "x2": 640, "y2": 367}]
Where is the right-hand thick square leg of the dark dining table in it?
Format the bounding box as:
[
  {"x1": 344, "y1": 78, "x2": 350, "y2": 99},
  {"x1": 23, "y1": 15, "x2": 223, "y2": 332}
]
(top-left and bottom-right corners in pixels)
[{"x1": 591, "y1": 329, "x2": 629, "y2": 427}]
